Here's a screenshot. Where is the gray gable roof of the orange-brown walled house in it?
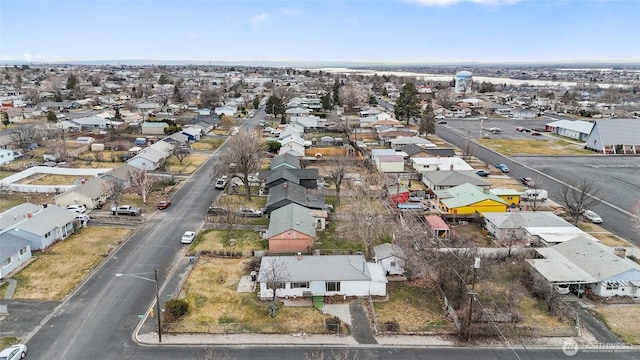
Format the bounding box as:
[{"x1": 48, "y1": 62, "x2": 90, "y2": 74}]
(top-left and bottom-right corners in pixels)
[{"x1": 267, "y1": 203, "x2": 316, "y2": 238}]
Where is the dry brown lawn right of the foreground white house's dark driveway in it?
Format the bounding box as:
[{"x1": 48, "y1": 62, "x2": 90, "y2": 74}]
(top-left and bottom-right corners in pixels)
[{"x1": 373, "y1": 282, "x2": 449, "y2": 332}]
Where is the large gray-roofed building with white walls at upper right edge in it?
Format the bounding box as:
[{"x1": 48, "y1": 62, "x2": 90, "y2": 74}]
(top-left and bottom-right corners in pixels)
[{"x1": 584, "y1": 119, "x2": 640, "y2": 154}]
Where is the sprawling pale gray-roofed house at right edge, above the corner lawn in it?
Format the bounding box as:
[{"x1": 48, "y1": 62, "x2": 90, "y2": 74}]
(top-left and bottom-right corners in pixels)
[{"x1": 527, "y1": 237, "x2": 640, "y2": 299}]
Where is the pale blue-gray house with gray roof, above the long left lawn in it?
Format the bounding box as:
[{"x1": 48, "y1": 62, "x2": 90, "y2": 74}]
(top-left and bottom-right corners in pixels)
[{"x1": 8, "y1": 205, "x2": 77, "y2": 250}]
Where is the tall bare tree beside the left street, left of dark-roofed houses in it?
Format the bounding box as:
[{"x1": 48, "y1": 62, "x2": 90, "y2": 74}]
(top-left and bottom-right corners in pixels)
[{"x1": 222, "y1": 131, "x2": 266, "y2": 201}]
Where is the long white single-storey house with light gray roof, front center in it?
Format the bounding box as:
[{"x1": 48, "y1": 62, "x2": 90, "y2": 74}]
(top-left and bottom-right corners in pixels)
[{"x1": 258, "y1": 254, "x2": 387, "y2": 300}]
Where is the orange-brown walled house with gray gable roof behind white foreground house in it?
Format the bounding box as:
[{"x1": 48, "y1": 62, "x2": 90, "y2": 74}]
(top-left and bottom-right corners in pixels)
[{"x1": 266, "y1": 203, "x2": 318, "y2": 253}]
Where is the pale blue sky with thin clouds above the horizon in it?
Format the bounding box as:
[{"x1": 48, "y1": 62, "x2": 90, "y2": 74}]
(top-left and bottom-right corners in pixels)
[{"x1": 0, "y1": 0, "x2": 640, "y2": 63}]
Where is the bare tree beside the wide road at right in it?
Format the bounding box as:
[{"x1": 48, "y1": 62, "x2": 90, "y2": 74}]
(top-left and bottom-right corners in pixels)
[{"x1": 560, "y1": 179, "x2": 600, "y2": 224}]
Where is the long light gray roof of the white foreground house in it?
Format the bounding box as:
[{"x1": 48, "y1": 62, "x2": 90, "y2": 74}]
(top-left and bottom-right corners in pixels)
[{"x1": 258, "y1": 255, "x2": 371, "y2": 282}]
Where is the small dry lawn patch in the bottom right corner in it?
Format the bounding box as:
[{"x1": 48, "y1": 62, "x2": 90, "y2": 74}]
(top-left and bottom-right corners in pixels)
[{"x1": 595, "y1": 304, "x2": 640, "y2": 345}]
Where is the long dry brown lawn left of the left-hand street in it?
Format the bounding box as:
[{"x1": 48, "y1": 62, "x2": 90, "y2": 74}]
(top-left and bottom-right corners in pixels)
[{"x1": 14, "y1": 226, "x2": 131, "y2": 301}]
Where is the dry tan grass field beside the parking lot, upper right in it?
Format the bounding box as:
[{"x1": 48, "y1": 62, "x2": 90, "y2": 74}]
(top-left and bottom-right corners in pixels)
[{"x1": 476, "y1": 138, "x2": 593, "y2": 156}]
